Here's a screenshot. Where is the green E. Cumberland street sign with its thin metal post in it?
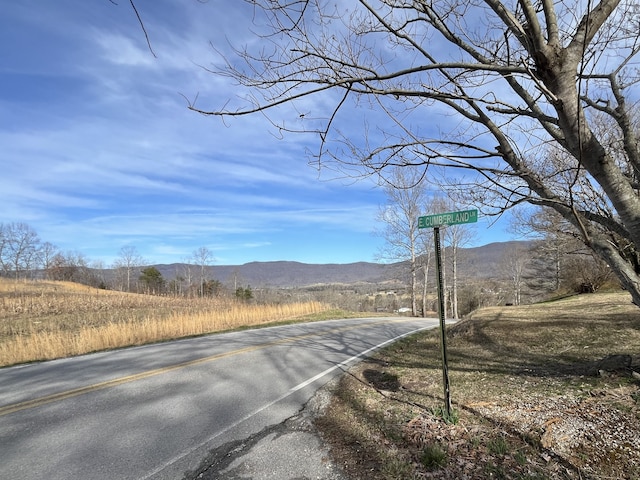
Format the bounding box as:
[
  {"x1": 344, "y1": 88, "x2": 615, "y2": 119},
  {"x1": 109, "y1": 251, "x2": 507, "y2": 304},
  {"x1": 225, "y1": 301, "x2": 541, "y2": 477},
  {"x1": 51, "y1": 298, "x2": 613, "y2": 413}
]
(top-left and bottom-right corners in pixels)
[{"x1": 418, "y1": 210, "x2": 478, "y2": 419}]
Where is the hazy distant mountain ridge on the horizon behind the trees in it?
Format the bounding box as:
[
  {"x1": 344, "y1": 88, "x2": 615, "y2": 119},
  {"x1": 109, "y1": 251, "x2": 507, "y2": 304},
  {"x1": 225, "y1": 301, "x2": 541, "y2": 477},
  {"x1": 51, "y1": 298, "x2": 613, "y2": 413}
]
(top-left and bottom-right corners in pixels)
[{"x1": 154, "y1": 241, "x2": 532, "y2": 288}]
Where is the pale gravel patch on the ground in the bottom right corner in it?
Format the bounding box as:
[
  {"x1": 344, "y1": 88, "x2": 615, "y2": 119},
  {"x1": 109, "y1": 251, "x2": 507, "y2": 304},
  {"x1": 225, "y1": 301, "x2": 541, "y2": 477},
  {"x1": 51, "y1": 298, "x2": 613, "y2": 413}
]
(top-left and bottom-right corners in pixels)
[{"x1": 471, "y1": 385, "x2": 640, "y2": 478}]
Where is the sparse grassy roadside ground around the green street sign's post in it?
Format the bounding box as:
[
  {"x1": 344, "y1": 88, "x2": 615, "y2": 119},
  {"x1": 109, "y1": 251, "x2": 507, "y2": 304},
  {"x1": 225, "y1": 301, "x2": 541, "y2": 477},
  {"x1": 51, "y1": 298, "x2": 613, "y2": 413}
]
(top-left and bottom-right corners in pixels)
[{"x1": 317, "y1": 292, "x2": 640, "y2": 480}]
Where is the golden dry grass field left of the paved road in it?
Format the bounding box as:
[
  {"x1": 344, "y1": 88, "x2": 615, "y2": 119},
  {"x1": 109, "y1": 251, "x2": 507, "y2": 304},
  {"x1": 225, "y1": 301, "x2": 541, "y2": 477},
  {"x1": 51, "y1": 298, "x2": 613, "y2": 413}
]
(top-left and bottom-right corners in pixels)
[{"x1": 0, "y1": 278, "x2": 329, "y2": 366}]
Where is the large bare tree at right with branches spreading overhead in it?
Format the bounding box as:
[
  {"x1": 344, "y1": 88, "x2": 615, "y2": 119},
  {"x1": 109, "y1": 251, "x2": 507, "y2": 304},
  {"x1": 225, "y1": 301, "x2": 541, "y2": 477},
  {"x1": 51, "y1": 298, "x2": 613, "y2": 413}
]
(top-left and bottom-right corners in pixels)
[{"x1": 190, "y1": 0, "x2": 640, "y2": 305}]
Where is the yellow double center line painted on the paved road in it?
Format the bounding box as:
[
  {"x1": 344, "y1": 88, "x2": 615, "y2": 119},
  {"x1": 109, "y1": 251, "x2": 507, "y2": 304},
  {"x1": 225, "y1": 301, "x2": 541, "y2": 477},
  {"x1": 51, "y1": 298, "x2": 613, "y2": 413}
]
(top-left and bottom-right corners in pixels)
[{"x1": 0, "y1": 320, "x2": 402, "y2": 417}]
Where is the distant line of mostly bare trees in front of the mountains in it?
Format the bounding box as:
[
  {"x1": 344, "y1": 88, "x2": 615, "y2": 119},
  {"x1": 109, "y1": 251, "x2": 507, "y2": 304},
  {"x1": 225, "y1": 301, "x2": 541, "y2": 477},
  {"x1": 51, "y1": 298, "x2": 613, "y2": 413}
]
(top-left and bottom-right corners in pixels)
[{"x1": 0, "y1": 217, "x2": 614, "y2": 318}]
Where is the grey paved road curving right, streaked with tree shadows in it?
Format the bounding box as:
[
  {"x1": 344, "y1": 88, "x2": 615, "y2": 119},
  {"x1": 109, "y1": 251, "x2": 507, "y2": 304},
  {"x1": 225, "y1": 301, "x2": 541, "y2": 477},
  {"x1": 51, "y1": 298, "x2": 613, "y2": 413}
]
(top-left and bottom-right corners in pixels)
[{"x1": 0, "y1": 317, "x2": 437, "y2": 480}]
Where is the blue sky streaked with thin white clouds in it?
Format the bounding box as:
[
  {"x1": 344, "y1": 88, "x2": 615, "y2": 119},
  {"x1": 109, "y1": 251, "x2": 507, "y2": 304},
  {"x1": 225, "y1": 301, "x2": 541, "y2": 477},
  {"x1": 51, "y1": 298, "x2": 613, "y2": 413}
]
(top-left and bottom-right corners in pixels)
[{"x1": 0, "y1": 0, "x2": 509, "y2": 265}]
